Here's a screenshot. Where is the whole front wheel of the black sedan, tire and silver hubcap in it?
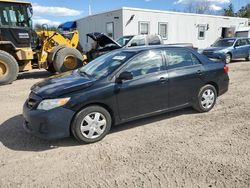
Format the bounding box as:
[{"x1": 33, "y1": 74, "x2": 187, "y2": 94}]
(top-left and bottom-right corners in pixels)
[{"x1": 71, "y1": 106, "x2": 112, "y2": 144}]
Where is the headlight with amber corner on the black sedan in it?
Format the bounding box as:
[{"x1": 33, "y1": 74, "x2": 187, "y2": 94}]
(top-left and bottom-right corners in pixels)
[{"x1": 37, "y1": 97, "x2": 70, "y2": 110}]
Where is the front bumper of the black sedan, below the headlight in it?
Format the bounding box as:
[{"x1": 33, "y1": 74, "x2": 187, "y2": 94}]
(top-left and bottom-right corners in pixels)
[{"x1": 23, "y1": 102, "x2": 74, "y2": 140}]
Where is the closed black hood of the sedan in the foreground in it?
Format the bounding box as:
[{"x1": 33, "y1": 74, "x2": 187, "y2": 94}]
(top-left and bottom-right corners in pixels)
[{"x1": 31, "y1": 70, "x2": 95, "y2": 99}]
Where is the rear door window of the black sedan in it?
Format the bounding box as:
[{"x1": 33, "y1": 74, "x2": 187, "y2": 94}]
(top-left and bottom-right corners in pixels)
[{"x1": 166, "y1": 50, "x2": 200, "y2": 69}]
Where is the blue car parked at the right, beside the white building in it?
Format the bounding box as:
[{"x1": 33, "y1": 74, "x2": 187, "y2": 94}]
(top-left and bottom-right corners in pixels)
[{"x1": 202, "y1": 38, "x2": 250, "y2": 63}]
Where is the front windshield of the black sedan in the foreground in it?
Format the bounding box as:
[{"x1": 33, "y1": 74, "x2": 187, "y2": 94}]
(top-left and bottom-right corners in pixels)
[{"x1": 79, "y1": 51, "x2": 135, "y2": 79}]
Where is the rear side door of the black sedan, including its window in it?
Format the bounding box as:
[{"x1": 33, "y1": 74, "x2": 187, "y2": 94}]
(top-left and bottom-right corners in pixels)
[{"x1": 165, "y1": 49, "x2": 204, "y2": 108}]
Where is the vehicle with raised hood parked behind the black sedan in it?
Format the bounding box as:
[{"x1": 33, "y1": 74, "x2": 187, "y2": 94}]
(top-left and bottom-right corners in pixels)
[{"x1": 87, "y1": 32, "x2": 163, "y2": 60}]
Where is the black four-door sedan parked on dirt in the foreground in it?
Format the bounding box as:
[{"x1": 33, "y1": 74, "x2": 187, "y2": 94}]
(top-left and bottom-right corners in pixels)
[{"x1": 23, "y1": 46, "x2": 229, "y2": 143}]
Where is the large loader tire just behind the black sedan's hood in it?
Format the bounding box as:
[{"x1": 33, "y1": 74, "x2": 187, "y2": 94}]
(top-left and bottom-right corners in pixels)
[{"x1": 53, "y1": 48, "x2": 83, "y2": 73}]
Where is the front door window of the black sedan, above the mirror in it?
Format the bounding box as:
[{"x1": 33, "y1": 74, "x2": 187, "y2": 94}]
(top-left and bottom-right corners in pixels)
[{"x1": 125, "y1": 51, "x2": 164, "y2": 77}]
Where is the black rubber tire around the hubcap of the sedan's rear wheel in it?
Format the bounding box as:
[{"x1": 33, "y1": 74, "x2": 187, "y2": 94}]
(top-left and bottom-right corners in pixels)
[{"x1": 193, "y1": 84, "x2": 217, "y2": 112}]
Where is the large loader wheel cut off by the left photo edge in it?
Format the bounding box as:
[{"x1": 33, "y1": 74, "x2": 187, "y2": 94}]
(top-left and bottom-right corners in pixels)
[{"x1": 0, "y1": 50, "x2": 19, "y2": 85}]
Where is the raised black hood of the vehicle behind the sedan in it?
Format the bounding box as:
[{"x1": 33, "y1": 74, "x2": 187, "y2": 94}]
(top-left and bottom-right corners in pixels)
[{"x1": 87, "y1": 32, "x2": 122, "y2": 48}]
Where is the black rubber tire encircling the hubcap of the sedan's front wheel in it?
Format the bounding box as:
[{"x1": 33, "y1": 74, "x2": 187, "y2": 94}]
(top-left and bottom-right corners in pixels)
[{"x1": 71, "y1": 106, "x2": 112, "y2": 144}]
